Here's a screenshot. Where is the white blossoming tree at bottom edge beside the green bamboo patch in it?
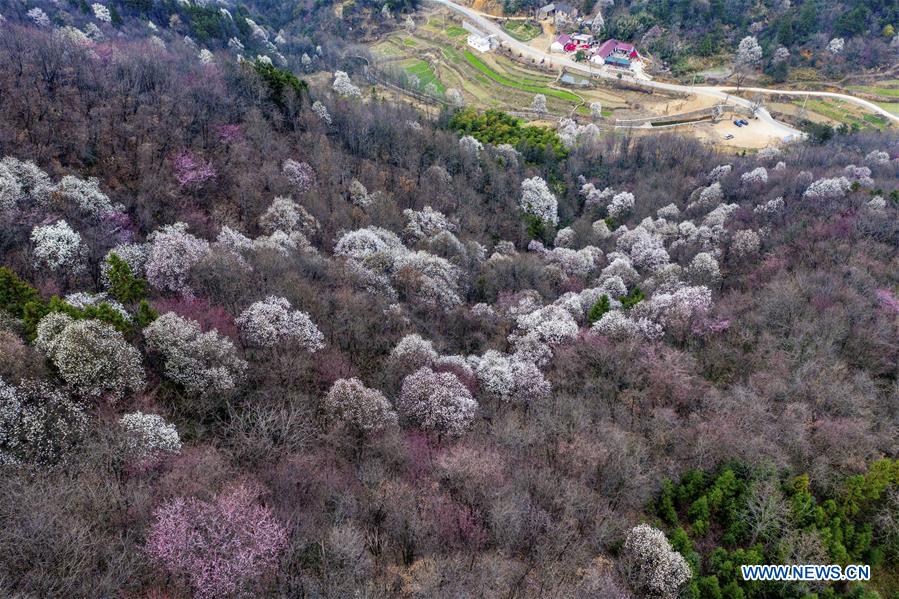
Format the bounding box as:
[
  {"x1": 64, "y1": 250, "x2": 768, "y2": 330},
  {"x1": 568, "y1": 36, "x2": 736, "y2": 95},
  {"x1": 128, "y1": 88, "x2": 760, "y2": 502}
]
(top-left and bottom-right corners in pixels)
[{"x1": 621, "y1": 524, "x2": 692, "y2": 599}]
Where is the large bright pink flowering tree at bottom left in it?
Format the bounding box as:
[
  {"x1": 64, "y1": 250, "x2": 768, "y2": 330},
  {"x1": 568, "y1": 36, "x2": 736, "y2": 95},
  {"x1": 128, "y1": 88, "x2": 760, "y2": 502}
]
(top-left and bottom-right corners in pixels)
[{"x1": 146, "y1": 485, "x2": 287, "y2": 599}]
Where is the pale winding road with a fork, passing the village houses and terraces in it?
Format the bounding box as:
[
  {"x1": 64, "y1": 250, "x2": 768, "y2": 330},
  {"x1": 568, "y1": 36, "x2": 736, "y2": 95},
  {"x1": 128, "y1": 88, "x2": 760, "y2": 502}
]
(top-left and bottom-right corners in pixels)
[{"x1": 428, "y1": 0, "x2": 899, "y2": 141}]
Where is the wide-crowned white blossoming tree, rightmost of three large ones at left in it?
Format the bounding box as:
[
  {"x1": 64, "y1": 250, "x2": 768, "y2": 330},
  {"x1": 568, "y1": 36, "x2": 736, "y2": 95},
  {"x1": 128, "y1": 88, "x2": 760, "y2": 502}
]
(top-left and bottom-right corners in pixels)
[{"x1": 236, "y1": 296, "x2": 325, "y2": 353}]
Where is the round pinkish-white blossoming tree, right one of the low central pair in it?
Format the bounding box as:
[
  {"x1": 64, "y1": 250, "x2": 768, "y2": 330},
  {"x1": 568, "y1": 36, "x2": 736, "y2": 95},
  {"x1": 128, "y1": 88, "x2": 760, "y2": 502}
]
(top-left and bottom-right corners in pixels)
[{"x1": 398, "y1": 367, "x2": 478, "y2": 436}]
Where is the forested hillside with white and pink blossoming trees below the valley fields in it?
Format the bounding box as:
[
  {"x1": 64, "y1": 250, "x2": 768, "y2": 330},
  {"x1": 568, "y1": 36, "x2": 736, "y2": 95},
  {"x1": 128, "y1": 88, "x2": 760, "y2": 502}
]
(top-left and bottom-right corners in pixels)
[{"x1": 0, "y1": 12, "x2": 899, "y2": 599}]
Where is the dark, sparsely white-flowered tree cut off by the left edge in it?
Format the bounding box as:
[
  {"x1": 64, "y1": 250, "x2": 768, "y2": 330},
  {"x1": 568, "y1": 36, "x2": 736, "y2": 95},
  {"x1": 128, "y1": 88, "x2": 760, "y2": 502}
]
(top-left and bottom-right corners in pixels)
[{"x1": 0, "y1": 378, "x2": 88, "y2": 466}]
